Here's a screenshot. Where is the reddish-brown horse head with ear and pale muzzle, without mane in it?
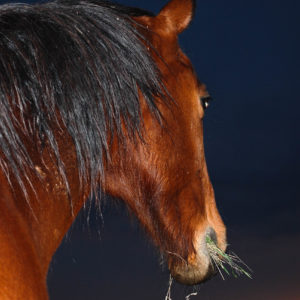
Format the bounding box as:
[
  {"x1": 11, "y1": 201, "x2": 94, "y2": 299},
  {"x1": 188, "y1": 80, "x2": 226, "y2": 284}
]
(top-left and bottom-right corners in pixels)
[{"x1": 104, "y1": 0, "x2": 226, "y2": 284}]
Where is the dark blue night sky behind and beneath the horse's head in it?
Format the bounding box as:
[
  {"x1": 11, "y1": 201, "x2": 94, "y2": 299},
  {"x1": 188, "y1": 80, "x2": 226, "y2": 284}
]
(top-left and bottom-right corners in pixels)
[{"x1": 2, "y1": 0, "x2": 300, "y2": 300}]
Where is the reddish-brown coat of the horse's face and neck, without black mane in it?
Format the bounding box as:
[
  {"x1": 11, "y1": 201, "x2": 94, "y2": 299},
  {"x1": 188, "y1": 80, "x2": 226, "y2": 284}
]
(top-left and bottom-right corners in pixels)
[{"x1": 0, "y1": 0, "x2": 226, "y2": 299}]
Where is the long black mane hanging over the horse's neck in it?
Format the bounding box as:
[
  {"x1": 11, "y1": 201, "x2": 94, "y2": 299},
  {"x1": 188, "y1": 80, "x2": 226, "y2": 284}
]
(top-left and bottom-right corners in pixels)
[{"x1": 0, "y1": 0, "x2": 166, "y2": 197}]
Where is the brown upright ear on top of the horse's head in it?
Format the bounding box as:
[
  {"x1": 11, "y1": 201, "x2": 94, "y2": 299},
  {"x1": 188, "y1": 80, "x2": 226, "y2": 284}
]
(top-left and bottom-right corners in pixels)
[{"x1": 158, "y1": 0, "x2": 196, "y2": 34}]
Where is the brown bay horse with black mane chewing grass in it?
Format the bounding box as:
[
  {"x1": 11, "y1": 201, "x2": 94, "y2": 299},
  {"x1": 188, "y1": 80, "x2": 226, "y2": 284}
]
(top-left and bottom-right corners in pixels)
[{"x1": 0, "y1": 0, "x2": 226, "y2": 299}]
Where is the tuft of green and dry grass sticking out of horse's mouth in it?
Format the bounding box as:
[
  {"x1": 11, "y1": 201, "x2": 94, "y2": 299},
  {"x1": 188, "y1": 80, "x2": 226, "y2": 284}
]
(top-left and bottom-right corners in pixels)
[{"x1": 206, "y1": 236, "x2": 252, "y2": 280}]
